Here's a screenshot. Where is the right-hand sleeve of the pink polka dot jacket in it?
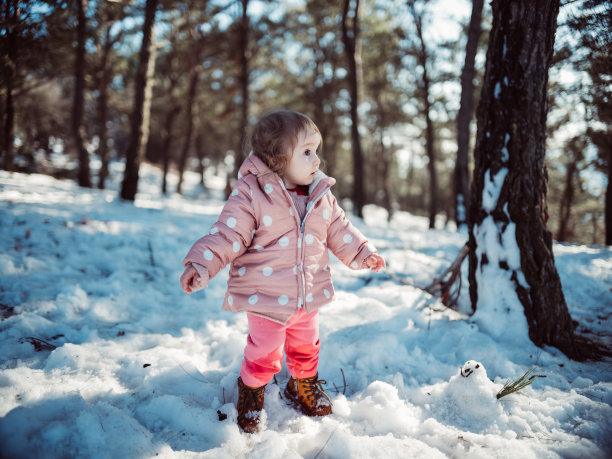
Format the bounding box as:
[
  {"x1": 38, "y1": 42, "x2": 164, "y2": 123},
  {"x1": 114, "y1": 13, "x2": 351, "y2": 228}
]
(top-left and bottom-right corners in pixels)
[{"x1": 327, "y1": 195, "x2": 376, "y2": 269}]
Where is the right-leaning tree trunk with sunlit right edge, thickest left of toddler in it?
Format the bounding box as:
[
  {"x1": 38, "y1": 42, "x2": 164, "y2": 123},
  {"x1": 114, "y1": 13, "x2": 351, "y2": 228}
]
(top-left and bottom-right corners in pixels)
[{"x1": 121, "y1": 0, "x2": 158, "y2": 201}]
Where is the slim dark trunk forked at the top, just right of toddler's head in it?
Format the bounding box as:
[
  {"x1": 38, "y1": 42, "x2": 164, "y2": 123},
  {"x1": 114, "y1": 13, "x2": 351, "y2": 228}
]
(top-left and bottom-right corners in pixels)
[{"x1": 342, "y1": 0, "x2": 365, "y2": 218}]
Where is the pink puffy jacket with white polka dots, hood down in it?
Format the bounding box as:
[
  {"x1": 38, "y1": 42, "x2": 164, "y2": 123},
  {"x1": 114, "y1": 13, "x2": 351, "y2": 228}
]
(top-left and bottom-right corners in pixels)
[{"x1": 183, "y1": 155, "x2": 376, "y2": 322}]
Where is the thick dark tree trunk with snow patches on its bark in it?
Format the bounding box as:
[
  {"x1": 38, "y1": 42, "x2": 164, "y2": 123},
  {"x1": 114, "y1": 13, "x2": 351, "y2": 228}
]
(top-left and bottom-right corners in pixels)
[{"x1": 469, "y1": 0, "x2": 584, "y2": 358}]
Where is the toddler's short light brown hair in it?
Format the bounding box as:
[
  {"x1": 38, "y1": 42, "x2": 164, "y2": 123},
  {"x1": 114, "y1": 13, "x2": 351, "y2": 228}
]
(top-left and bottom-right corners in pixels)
[{"x1": 250, "y1": 110, "x2": 321, "y2": 173}]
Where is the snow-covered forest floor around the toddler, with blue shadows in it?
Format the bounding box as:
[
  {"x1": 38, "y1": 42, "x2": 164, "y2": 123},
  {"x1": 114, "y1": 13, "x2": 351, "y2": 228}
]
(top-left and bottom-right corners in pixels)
[{"x1": 0, "y1": 165, "x2": 612, "y2": 459}]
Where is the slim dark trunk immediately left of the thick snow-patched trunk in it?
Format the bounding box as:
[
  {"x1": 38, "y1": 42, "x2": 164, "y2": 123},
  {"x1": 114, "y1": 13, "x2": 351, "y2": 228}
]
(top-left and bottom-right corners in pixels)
[{"x1": 454, "y1": 0, "x2": 484, "y2": 228}]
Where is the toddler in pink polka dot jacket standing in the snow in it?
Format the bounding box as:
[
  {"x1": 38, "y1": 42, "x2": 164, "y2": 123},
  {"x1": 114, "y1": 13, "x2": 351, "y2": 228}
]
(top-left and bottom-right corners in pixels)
[{"x1": 180, "y1": 110, "x2": 385, "y2": 433}]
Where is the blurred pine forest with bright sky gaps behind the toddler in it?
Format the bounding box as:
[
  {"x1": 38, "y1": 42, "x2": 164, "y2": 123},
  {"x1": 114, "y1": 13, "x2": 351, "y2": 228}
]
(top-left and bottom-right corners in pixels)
[{"x1": 0, "y1": 0, "x2": 612, "y2": 245}]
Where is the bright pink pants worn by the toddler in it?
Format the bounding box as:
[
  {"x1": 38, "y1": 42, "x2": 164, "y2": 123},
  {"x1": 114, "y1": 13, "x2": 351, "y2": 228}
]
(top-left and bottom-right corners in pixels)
[{"x1": 240, "y1": 309, "x2": 320, "y2": 387}]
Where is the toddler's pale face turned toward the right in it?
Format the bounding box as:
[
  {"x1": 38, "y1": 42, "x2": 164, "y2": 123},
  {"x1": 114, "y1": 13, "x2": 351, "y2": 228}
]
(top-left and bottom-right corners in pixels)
[{"x1": 282, "y1": 129, "x2": 321, "y2": 188}]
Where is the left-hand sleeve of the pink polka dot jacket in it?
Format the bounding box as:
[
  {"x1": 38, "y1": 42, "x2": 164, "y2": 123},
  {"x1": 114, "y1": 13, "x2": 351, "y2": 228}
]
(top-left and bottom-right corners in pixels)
[{"x1": 183, "y1": 180, "x2": 257, "y2": 279}]
